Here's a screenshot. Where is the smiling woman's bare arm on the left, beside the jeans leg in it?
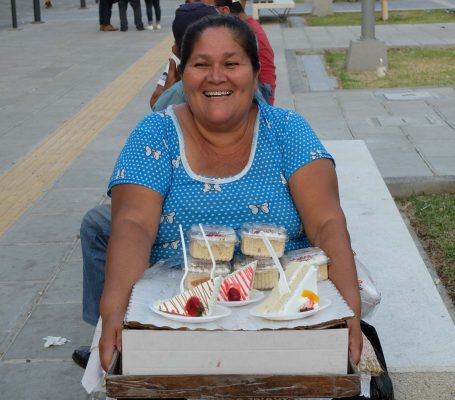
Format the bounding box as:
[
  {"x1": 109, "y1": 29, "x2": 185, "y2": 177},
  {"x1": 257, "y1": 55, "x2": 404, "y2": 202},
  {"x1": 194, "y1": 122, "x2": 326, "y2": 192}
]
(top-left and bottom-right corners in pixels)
[{"x1": 99, "y1": 184, "x2": 163, "y2": 370}]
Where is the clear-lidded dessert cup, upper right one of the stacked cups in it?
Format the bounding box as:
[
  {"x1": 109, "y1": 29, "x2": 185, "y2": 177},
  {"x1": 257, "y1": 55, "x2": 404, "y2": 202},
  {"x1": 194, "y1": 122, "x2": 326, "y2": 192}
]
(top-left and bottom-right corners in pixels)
[{"x1": 240, "y1": 222, "x2": 288, "y2": 257}]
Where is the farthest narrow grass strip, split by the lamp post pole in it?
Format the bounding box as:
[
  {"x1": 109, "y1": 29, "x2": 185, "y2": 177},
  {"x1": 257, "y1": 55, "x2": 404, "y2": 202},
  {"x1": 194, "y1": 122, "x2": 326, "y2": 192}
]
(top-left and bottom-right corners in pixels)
[{"x1": 303, "y1": 10, "x2": 455, "y2": 26}]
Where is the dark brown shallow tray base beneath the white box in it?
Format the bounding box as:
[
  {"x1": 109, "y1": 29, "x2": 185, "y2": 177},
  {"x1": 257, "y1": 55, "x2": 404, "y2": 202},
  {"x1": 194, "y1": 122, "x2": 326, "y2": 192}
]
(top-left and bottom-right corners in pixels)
[{"x1": 106, "y1": 353, "x2": 360, "y2": 400}]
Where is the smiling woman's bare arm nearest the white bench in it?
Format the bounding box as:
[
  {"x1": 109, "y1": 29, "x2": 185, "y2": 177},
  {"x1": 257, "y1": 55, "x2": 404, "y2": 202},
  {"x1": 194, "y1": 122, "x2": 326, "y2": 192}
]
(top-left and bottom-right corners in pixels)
[{"x1": 289, "y1": 158, "x2": 362, "y2": 363}]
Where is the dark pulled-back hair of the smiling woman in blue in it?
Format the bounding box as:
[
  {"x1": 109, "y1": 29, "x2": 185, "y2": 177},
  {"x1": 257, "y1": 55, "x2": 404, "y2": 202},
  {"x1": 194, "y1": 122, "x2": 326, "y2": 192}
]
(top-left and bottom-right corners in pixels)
[{"x1": 179, "y1": 15, "x2": 260, "y2": 74}]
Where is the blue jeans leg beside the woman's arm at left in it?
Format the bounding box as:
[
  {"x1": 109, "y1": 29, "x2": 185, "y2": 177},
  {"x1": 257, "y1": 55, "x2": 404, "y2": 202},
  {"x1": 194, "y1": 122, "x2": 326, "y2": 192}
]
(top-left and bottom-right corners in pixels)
[{"x1": 80, "y1": 205, "x2": 111, "y2": 326}]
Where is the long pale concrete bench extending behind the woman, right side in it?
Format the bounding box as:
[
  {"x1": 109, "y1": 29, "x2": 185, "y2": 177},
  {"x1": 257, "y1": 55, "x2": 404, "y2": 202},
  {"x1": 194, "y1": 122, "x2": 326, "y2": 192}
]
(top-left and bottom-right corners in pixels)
[{"x1": 324, "y1": 140, "x2": 455, "y2": 399}]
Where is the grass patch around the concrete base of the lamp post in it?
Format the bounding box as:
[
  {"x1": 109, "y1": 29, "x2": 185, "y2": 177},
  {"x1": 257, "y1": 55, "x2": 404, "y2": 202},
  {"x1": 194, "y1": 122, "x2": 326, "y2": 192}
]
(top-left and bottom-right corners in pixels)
[{"x1": 325, "y1": 48, "x2": 455, "y2": 89}]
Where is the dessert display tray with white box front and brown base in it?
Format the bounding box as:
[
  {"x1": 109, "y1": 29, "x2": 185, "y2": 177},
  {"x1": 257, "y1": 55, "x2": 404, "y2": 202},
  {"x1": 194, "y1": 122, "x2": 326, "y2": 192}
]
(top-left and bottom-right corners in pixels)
[{"x1": 105, "y1": 266, "x2": 360, "y2": 400}]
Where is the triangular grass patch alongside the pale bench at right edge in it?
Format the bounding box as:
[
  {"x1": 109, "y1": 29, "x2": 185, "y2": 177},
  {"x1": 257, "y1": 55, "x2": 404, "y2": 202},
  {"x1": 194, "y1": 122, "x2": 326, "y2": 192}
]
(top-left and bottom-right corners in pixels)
[{"x1": 397, "y1": 195, "x2": 455, "y2": 303}]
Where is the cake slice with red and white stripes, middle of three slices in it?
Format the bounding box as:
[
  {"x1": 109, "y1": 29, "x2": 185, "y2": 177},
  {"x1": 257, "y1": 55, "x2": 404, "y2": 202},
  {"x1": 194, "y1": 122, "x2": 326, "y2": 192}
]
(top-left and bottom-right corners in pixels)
[{"x1": 218, "y1": 261, "x2": 257, "y2": 301}]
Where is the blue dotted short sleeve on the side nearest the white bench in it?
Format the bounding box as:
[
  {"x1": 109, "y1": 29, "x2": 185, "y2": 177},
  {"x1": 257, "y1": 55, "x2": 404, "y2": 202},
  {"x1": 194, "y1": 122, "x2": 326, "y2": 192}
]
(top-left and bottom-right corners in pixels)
[{"x1": 281, "y1": 110, "x2": 334, "y2": 179}]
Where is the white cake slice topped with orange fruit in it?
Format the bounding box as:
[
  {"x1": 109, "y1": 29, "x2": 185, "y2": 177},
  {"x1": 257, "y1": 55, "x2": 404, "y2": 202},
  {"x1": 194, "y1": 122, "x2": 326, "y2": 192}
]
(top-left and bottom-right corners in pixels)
[{"x1": 257, "y1": 265, "x2": 319, "y2": 314}]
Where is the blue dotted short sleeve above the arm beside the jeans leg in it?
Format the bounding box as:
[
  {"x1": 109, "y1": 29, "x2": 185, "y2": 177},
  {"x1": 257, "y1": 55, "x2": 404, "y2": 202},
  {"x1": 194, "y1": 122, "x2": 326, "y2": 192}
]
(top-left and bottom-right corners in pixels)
[{"x1": 108, "y1": 113, "x2": 172, "y2": 196}]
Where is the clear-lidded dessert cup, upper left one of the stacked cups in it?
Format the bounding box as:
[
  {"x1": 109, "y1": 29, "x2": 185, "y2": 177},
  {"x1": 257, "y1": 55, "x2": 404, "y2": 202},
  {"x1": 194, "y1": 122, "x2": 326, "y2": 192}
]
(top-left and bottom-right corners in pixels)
[{"x1": 188, "y1": 225, "x2": 237, "y2": 261}]
